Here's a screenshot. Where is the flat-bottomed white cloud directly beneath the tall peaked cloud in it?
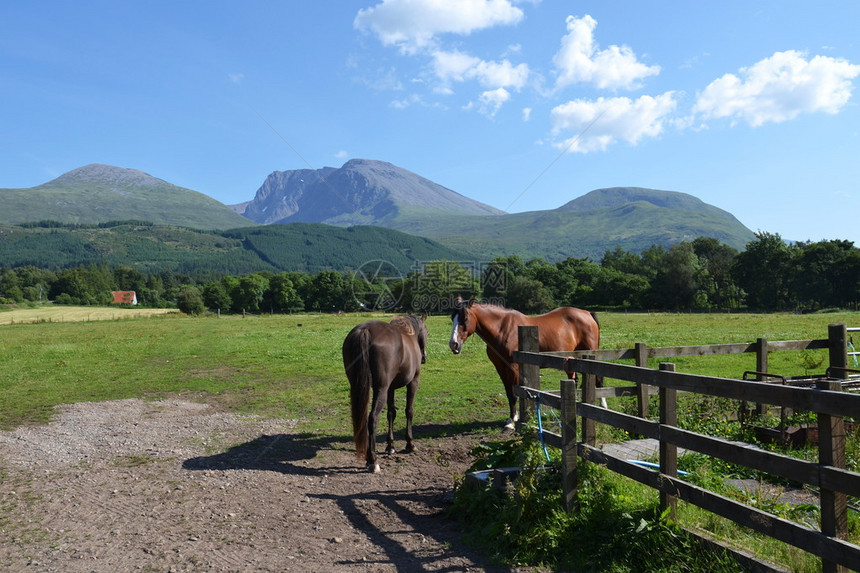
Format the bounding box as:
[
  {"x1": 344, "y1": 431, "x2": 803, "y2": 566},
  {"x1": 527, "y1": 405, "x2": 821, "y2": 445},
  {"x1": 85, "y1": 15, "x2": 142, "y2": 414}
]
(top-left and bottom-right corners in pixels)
[{"x1": 550, "y1": 91, "x2": 677, "y2": 153}]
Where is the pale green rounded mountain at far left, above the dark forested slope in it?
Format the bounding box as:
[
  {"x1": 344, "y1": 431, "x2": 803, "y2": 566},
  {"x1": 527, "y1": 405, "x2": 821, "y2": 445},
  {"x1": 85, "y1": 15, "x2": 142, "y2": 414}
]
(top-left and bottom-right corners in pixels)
[{"x1": 0, "y1": 164, "x2": 253, "y2": 229}]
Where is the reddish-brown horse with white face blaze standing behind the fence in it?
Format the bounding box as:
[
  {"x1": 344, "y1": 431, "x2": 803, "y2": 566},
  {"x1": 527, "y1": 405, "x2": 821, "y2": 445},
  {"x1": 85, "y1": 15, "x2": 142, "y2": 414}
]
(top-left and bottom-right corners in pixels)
[{"x1": 448, "y1": 297, "x2": 600, "y2": 428}]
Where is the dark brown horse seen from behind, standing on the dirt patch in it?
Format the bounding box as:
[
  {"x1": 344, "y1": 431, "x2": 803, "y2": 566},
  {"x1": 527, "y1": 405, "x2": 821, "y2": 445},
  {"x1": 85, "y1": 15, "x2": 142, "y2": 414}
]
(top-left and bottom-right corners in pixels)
[{"x1": 343, "y1": 315, "x2": 427, "y2": 473}]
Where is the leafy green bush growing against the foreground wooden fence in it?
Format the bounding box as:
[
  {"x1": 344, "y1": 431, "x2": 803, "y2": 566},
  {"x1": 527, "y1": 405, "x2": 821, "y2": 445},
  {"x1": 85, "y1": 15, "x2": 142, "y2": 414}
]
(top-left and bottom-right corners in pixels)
[{"x1": 451, "y1": 436, "x2": 743, "y2": 572}]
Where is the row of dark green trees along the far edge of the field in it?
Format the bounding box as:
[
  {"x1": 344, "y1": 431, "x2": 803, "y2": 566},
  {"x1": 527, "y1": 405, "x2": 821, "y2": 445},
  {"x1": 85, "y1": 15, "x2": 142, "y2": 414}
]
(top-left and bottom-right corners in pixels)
[{"x1": 0, "y1": 233, "x2": 860, "y2": 314}]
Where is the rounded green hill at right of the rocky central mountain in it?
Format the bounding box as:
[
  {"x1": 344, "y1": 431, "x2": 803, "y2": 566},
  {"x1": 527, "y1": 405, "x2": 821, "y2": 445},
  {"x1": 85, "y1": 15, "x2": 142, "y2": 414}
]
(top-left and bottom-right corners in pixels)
[{"x1": 396, "y1": 188, "x2": 755, "y2": 261}]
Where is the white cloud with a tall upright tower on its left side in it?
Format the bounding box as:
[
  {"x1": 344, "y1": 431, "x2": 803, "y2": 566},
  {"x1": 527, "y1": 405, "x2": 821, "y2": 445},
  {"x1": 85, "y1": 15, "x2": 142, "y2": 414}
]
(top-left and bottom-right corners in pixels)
[{"x1": 553, "y1": 16, "x2": 660, "y2": 89}]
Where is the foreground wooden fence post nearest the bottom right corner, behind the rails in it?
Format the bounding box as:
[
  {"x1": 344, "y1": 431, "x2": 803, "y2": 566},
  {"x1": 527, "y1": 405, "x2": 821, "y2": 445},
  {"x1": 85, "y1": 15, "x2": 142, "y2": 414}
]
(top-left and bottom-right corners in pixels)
[{"x1": 816, "y1": 380, "x2": 848, "y2": 573}]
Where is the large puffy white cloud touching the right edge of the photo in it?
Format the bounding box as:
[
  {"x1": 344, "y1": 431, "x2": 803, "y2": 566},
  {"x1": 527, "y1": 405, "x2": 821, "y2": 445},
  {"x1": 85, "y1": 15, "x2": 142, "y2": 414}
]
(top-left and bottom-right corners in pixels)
[{"x1": 693, "y1": 50, "x2": 860, "y2": 127}]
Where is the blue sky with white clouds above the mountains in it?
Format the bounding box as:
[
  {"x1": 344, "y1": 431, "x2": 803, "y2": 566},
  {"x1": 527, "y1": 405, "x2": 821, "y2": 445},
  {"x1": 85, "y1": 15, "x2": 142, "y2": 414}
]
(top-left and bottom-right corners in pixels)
[{"x1": 0, "y1": 0, "x2": 860, "y2": 246}]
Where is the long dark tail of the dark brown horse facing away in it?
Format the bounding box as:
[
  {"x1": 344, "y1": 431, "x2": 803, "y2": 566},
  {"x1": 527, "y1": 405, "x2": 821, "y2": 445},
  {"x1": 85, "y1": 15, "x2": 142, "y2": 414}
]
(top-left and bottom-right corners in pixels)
[{"x1": 343, "y1": 328, "x2": 372, "y2": 459}]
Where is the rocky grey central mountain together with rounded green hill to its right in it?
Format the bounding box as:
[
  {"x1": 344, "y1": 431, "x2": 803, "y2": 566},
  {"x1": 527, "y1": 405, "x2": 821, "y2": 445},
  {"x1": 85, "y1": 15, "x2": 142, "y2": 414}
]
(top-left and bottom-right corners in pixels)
[{"x1": 235, "y1": 159, "x2": 755, "y2": 261}]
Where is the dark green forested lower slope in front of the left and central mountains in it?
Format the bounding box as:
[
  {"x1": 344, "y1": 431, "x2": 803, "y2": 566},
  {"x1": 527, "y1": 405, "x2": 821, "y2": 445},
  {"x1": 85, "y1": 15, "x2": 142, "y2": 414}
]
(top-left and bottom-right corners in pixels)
[{"x1": 0, "y1": 222, "x2": 464, "y2": 275}]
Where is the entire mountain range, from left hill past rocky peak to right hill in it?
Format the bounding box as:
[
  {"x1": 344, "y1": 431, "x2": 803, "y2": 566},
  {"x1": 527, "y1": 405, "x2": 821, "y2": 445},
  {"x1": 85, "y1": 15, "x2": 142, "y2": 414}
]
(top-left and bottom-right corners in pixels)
[{"x1": 0, "y1": 159, "x2": 755, "y2": 270}]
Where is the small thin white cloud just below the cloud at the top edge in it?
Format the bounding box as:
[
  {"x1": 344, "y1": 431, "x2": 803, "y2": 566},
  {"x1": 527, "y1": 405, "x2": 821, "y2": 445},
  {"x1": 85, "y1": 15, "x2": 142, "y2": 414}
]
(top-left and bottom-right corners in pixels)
[{"x1": 432, "y1": 51, "x2": 529, "y2": 90}]
